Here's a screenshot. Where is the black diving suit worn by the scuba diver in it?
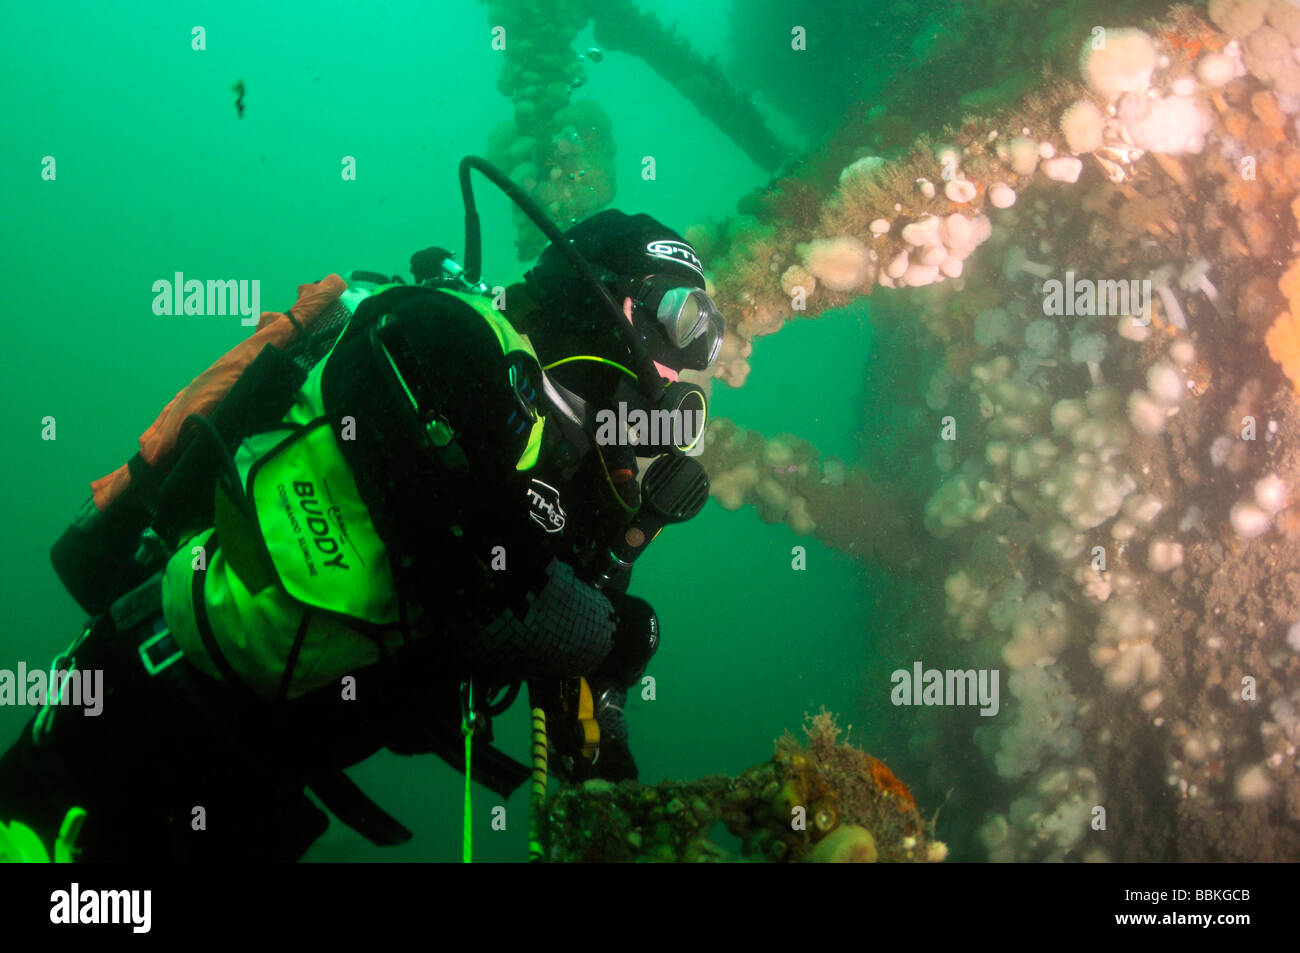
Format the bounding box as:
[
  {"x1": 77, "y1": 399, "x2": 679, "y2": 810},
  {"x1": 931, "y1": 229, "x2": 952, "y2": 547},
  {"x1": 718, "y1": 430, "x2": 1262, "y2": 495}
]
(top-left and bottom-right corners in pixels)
[{"x1": 0, "y1": 284, "x2": 639, "y2": 859}]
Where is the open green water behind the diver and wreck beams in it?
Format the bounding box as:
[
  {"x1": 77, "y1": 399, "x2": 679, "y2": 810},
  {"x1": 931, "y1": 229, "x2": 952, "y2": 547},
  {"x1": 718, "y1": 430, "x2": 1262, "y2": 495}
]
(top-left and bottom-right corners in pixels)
[{"x1": 0, "y1": 0, "x2": 911, "y2": 859}]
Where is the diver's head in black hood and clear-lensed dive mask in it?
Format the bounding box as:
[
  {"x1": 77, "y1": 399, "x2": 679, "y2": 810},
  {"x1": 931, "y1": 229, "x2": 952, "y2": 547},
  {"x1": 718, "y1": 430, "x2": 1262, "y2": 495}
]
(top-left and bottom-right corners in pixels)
[{"x1": 525, "y1": 209, "x2": 727, "y2": 380}]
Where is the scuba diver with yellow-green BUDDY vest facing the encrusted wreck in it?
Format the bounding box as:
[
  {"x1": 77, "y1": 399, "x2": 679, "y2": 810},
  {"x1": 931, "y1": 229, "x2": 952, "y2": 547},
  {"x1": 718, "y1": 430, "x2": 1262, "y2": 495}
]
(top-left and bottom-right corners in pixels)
[{"x1": 0, "y1": 156, "x2": 724, "y2": 861}]
